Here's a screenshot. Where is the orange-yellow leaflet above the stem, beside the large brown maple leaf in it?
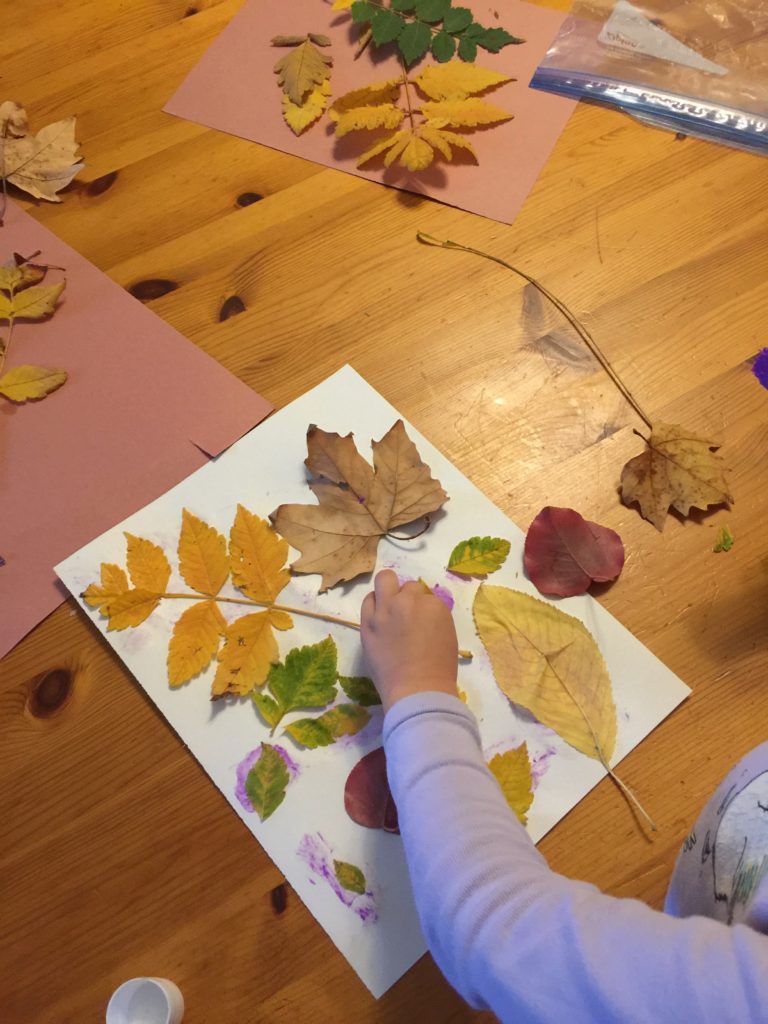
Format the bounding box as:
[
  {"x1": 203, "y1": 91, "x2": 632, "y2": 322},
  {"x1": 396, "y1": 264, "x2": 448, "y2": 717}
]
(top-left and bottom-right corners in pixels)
[{"x1": 229, "y1": 505, "x2": 291, "y2": 601}]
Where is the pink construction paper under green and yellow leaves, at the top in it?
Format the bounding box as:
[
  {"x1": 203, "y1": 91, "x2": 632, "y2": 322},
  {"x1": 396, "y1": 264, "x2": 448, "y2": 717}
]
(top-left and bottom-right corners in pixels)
[{"x1": 165, "y1": 0, "x2": 575, "y2": 223}]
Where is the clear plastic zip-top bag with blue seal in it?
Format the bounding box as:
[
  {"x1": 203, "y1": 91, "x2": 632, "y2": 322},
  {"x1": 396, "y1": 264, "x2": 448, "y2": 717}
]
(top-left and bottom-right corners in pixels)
[{"x1": 530, "y1": 0, "x2": 768, "y2": 154}]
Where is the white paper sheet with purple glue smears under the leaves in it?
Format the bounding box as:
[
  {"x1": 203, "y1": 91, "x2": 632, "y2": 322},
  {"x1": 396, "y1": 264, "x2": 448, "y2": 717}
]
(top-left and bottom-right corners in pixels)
[{"x1": 56, "y1": 367, "x2": 689, "y2": 997}]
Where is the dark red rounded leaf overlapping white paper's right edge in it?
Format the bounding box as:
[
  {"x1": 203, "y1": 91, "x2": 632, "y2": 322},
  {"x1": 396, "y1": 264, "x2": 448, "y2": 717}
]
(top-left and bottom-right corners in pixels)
[{"x1": 523, "y1": 505, "x2": 624, "y2": 597}]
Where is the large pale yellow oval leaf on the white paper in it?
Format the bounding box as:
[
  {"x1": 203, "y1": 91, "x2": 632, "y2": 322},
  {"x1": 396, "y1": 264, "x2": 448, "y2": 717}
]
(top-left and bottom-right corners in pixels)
[{"x1": 473, "y1": 584, "x2": 616, "y2": 768}]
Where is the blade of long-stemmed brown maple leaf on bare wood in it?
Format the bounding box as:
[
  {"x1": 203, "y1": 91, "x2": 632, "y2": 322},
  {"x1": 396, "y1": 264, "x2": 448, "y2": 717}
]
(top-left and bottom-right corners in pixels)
[{"x1": 622, "y1": 423, "x2": 733, "y2": 530}]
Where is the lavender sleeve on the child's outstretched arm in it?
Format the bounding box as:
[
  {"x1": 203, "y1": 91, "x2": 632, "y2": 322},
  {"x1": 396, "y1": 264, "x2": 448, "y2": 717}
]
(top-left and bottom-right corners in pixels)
[{"x1": 384, "y1": 693, "x2": 768, "y2": 1024}]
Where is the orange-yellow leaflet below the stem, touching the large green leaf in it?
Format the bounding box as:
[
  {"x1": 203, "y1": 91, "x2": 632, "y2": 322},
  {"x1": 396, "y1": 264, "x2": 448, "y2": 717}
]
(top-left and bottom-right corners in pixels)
[{"x1": 211, "y1": 611, "x2": 280, "y2": 697}]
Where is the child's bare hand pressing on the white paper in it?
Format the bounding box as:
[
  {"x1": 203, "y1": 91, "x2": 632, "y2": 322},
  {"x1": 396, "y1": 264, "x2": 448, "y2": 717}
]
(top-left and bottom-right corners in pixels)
[{"x1": 360, "y1": 569, "x2": 459, "y2": 711}]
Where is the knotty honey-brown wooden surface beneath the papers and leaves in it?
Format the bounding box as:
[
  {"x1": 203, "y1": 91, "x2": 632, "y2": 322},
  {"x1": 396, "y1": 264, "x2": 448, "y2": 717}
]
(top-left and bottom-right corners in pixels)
[{"x1": 0, "y1": 0, "x2": 768, "y2": 1024}]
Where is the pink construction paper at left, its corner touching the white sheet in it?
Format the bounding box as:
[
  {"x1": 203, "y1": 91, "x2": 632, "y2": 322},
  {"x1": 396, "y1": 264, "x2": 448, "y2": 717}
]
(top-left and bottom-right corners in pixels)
[{"x1": 0, "y1": 203, "x2": 272, "y2": 656}]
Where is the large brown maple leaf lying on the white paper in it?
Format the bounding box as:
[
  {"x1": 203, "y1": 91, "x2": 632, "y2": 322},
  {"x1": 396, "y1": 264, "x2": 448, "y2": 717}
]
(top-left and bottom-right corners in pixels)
[{"x1": 269, "y1": 420, "x2": 447, "y2": 593}]
